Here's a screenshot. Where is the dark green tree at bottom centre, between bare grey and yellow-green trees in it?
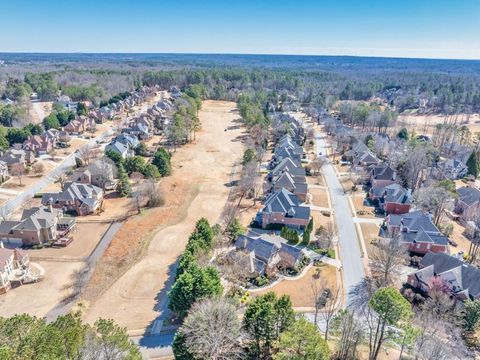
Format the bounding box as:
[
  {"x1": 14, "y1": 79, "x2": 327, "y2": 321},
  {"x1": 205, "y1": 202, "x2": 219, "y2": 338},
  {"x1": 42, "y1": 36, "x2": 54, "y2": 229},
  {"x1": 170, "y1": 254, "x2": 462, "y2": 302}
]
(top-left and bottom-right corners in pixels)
[{"x1": 243, "y1": 292, "x2": 294, "y2": 358}]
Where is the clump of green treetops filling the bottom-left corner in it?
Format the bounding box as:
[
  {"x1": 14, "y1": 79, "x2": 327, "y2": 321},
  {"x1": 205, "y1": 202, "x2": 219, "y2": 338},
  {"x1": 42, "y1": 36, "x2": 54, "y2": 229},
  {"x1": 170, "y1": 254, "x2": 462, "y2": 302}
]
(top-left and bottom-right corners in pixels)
[{"x1": 0, "y1": 313, "x2": 141, "y2": 360}]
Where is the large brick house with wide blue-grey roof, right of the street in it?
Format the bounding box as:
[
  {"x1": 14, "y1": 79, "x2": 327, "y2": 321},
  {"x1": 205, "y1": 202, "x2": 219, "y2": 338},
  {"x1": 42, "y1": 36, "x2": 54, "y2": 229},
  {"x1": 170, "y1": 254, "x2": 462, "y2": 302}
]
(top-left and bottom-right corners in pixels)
[{"x1": 386, "y1": 210, "x2": 449, "y2": 255}]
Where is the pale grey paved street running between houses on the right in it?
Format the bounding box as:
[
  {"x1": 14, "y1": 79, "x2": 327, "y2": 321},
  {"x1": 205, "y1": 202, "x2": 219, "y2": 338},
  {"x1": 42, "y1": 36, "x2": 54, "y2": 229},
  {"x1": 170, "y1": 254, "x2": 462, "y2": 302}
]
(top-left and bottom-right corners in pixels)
[{"x1": 315, "y1": 133, "x2": 365, "y2": 304}]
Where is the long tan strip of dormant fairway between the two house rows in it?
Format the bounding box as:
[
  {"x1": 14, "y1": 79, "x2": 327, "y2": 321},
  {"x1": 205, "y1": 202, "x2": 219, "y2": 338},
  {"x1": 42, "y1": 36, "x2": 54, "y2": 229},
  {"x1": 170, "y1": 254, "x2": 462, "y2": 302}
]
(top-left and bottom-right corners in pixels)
[{"x1": 82, "y1": 101, "x2": 243, "y2": 330}]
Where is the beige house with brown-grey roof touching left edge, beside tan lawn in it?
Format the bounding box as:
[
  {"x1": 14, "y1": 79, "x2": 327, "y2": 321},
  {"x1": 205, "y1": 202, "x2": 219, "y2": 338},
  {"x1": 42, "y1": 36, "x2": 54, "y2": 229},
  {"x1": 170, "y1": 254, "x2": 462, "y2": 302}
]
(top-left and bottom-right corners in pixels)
[{"x1": 0, "y1": 206, "x2": 76, "y2": 246}]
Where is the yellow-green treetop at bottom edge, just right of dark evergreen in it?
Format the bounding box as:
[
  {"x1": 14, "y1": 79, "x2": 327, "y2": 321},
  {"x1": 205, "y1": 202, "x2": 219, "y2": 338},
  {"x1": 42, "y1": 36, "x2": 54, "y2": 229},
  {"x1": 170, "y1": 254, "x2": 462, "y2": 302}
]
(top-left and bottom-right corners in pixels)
[{"x1": 273, "y1": 316, "x2": 330, "y2": 360}]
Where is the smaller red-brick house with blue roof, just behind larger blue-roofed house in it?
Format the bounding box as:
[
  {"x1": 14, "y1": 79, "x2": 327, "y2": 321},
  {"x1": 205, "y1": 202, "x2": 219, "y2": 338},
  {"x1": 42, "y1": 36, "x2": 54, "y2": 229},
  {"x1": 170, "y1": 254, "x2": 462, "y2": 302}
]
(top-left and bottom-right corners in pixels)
[{"x1": 369, "y1": 183, "x2": 413, "y2": 215}]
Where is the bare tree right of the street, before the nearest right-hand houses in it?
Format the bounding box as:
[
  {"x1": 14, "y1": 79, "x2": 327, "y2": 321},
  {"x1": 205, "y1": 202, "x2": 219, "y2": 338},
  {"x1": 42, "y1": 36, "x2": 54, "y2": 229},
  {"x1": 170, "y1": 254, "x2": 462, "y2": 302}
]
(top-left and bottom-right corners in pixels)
[{"x1": 369, "y1": 238, "x2": 407, "y2": 287}]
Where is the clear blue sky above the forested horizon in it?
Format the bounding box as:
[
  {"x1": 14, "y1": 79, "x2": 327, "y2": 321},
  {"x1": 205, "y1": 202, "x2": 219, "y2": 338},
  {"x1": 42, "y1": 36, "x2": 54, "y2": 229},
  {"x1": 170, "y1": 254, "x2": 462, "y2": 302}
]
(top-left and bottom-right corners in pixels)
[{"x1": 0, "y1": 0, "x2": 480, "y2": 59}]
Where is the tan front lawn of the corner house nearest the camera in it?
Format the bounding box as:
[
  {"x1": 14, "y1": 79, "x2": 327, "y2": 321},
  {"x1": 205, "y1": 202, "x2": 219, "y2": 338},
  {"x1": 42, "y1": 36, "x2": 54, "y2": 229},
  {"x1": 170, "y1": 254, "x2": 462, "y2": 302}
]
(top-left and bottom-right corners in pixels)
[{"x1": 255, "y1": 264, "x2": 337, "y2": 308}]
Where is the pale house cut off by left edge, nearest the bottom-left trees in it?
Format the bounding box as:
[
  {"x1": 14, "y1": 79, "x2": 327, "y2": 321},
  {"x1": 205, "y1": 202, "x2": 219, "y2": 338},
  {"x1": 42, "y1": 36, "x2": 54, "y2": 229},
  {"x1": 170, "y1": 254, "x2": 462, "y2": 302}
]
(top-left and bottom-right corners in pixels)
[{"x1": 0, "y1": 248, "x2": 30, "y2": 294}]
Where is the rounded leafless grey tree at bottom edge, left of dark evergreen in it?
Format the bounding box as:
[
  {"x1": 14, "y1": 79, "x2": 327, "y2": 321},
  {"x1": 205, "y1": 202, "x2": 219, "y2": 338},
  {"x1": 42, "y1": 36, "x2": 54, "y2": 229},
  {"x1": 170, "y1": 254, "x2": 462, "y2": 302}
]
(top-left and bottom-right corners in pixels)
[{"x1": 175, "y1": 298, "x2": 241, "y2": 360}]
